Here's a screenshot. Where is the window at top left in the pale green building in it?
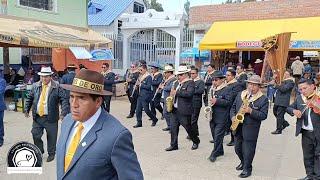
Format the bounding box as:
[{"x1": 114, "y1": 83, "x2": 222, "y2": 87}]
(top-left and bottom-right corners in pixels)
[{"x1": 18, "y1": 0, "x2": 55, "y2": 11}]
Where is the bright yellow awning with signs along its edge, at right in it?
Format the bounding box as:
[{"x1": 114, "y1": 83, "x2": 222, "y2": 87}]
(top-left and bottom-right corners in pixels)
[{"x1": 199, "y1": 17, "x2": 320, "y2": 51}]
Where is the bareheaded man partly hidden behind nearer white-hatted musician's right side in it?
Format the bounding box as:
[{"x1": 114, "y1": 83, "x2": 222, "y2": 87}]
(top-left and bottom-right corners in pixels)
[{"x1": 187, "y1": 67, "x2": 205, "y2": 139}]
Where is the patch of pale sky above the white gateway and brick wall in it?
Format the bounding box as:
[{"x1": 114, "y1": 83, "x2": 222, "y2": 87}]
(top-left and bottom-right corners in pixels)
[{"x1": 157, "y1": 0, "x2": 226, "y2": 12}]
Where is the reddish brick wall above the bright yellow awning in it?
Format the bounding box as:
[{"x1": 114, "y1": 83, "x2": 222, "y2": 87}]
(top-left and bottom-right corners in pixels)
[{"x1": 190, "y1": 0, "x2": 320, "y2": 29}]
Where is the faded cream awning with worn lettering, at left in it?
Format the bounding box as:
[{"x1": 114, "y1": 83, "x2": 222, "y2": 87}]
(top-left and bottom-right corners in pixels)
[{"x1": 0, "y1": 16, "x2": 111, "y2": 48}]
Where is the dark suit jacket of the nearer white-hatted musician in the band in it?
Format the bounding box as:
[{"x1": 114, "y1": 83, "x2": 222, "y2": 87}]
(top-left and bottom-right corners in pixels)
[{"x1": 174, "y1": 80, "x2": 195, "y2": 116}]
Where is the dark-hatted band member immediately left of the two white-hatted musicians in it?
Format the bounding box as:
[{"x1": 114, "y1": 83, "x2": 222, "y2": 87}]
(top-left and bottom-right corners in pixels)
[{"x1": 150, "y1": 63, "x2": 163, "y2": 119}]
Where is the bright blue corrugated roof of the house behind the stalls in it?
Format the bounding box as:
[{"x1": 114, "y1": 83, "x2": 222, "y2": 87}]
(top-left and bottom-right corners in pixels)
[{"x1": 88, "y1": 0, "x2": 134, "y2": 26}]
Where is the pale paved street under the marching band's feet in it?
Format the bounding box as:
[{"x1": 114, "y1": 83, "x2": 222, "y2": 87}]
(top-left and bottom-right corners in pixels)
[{"x1": 0, "y1": 97, "x2": 305, "y2": 180}]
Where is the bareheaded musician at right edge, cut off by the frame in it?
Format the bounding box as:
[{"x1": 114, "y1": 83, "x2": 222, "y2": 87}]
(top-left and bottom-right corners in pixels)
[{"x1": 287, "y1": 79, "x2": 320, "y2": 180}]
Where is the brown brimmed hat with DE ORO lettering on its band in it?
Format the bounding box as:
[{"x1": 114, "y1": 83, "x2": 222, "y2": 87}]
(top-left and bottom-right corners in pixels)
[{"x1": 60, "y1": 69, "x2": 112, "y2": 96}]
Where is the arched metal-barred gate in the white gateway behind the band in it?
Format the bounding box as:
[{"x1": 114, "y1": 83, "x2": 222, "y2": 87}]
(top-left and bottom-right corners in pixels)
[{"x1": 129, "y1": 29, "x2": 176, "y2": 65}]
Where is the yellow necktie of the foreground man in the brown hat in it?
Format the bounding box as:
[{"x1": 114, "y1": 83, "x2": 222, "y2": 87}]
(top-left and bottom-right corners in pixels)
[{"x1": 64, "y1": 123, "x2": 83, "y2": 172}]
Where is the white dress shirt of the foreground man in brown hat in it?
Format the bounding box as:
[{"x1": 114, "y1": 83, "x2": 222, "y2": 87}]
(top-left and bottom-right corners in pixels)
[{"x1": 66, "y1": 107, "x2": 101, "y2": 153}]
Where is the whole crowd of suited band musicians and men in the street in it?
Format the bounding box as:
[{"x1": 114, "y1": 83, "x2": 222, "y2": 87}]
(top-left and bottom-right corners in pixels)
[{"x1": 0, "y1": 56, "x2": 320, "y2": 179}]
